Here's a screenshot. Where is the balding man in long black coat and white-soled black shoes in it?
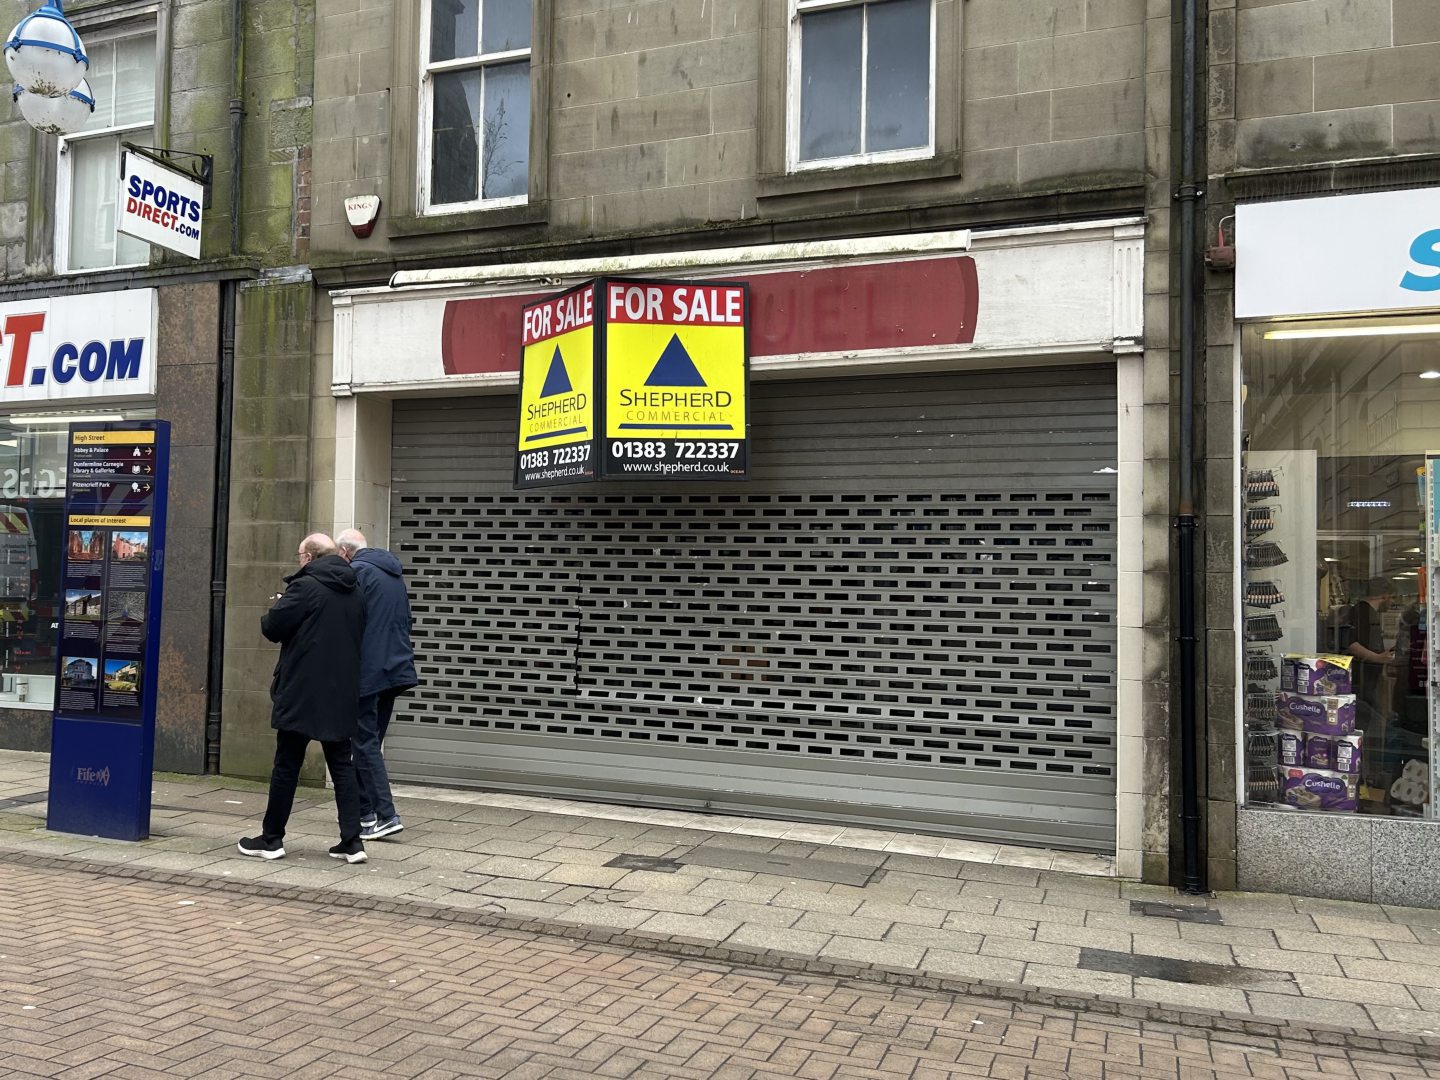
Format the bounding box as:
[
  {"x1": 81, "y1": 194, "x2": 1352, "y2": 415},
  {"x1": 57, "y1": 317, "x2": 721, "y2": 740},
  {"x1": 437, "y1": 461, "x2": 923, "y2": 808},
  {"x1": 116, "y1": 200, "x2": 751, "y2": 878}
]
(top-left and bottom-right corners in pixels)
[{"x1": 239, "y1": 533, "x2": 366, "y2": 863}]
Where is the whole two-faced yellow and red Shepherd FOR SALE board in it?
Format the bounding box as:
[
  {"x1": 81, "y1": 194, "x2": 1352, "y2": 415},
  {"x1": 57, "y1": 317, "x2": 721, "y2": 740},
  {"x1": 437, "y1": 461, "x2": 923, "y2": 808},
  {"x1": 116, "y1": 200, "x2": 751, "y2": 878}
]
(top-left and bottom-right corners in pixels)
[{"x1": 516, "y1": 278, "x2": 750, "y2": 488}]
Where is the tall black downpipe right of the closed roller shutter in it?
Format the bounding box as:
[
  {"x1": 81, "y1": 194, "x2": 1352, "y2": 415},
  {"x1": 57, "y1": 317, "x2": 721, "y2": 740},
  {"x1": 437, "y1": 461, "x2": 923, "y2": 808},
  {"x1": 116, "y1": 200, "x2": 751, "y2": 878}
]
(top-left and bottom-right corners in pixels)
[{"x1": 1175, "y1": 0, "x2": 1208, "y2": 896}]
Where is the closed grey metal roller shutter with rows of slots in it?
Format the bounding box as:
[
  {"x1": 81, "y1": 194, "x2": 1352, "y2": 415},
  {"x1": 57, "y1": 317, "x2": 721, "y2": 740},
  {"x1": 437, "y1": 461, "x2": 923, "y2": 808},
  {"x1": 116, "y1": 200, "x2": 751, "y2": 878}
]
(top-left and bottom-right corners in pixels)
[{"x1": 386, "y1": 367, "x2": 1116, "y2": 851}]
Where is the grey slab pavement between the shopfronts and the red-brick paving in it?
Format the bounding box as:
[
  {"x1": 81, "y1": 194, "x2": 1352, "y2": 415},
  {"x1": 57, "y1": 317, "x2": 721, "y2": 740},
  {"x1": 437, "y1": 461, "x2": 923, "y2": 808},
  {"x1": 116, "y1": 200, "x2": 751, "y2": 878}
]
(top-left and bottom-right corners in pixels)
[{"x1": 0, "y1": 752, "x2": 1440, "y2": 1057}]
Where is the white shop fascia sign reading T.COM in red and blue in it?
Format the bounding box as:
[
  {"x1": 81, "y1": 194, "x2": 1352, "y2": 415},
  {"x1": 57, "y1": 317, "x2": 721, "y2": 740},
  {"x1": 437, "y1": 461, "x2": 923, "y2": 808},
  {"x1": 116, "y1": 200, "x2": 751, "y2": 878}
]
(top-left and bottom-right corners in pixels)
[{"x1": 0, "y1": 289, "x2": 158, "y2": 408}]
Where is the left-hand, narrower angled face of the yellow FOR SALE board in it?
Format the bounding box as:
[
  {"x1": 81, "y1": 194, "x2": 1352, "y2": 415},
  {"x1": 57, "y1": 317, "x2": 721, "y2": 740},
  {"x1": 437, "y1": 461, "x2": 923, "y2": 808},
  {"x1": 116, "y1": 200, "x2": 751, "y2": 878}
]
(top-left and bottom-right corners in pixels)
[{"x1": 516, "y1": 282, "x2": 599, "y2": 488}]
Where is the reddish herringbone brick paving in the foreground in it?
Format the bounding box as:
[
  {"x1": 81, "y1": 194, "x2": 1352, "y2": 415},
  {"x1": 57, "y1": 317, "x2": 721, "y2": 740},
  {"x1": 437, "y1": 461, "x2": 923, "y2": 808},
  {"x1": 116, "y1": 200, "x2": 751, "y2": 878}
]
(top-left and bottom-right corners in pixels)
[{"x1": 0, "y1": 865, "x2": 1440, "y2": 1080}]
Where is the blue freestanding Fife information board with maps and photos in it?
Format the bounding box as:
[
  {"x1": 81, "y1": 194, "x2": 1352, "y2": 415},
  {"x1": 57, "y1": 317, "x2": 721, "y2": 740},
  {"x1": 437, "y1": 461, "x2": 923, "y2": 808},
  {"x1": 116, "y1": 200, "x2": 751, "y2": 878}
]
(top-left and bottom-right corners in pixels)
[{"x1": 46, "y1": 420, "x2": 170, "y2": 840}]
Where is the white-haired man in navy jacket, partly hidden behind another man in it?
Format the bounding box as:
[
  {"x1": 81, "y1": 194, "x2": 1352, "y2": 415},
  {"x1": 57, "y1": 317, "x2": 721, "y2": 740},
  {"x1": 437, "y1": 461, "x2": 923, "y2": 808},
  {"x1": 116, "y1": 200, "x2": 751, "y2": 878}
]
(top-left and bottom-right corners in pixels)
[{"x1": 337, "y1": 528, "x2": 418, "y2": 840}]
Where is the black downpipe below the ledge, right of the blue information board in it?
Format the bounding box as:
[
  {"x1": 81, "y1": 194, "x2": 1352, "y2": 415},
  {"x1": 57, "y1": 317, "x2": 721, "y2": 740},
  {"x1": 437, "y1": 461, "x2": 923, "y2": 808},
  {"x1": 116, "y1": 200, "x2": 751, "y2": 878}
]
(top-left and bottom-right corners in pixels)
[{"x1": 204, "y1": 281, "x2": 240, "y2": 775}]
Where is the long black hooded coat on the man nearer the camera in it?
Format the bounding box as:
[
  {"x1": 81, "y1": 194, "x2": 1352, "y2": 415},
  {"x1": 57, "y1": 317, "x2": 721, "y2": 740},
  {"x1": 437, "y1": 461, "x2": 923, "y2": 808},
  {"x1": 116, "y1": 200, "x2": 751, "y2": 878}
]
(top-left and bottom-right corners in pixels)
[{"x1": 261, "y1": 554, "x2": 364, "y2": 742}]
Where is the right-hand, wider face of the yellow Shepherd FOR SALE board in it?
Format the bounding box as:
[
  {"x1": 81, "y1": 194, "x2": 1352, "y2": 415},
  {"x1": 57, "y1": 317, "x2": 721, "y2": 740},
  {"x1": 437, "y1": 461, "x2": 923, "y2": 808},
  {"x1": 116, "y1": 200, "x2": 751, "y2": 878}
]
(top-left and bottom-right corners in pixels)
[{"x1": 600, "y1": 279, "x2": 750, "y2": 480}]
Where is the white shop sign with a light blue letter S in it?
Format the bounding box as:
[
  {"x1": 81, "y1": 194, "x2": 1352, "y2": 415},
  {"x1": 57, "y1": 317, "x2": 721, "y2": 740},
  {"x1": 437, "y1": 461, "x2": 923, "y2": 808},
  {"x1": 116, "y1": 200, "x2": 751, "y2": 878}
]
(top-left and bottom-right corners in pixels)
[{"x1": 1236, "y1": 187, "x2": 1440, "y2": 318}]
